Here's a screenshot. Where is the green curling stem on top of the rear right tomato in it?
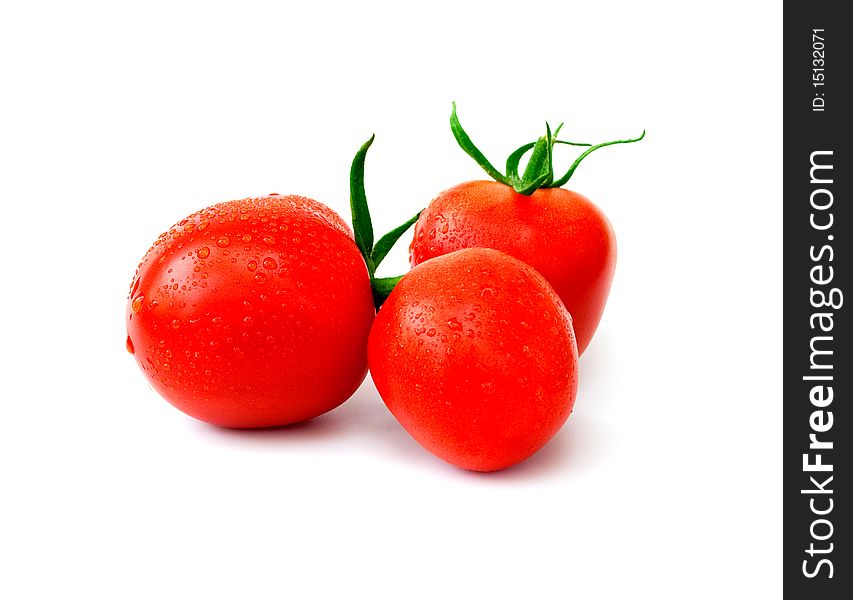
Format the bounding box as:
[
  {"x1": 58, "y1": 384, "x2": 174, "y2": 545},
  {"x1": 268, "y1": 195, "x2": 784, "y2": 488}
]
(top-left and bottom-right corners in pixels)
[{"x1": 450, "y1": 102, "x2": 646, "y2": 196}]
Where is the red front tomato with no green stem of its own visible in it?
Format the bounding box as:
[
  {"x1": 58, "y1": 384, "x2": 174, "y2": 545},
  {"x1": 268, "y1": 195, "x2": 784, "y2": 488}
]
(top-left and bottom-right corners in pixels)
[{"x1": 368, "y1": 248, "x2": 577, "y2": 471}]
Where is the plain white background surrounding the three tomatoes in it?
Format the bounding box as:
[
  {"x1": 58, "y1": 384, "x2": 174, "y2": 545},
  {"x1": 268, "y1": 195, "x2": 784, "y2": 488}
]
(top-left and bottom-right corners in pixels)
[{"x1": 0, "y1": 1, "x2": 781, "y2": 599}]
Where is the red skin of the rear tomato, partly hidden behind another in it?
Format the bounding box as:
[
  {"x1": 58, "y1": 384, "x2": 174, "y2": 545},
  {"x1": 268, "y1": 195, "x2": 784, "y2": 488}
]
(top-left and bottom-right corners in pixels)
[{"x1": 409, "y1": 181, "x2": 616, "y2": 354}]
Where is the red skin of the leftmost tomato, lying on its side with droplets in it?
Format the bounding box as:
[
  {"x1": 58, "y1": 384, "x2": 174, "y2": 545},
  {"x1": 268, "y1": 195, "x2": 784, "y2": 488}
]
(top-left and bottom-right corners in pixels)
[{"x1": 127, "y1": 194, "x2": 374, "y2": 427}]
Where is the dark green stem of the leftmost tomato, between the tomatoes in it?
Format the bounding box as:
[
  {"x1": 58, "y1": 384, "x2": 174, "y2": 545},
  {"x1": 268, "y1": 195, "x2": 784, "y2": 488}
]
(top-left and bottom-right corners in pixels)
[{"x1": 350, "y1": 135, "x2": 421, "y2": 310}]
